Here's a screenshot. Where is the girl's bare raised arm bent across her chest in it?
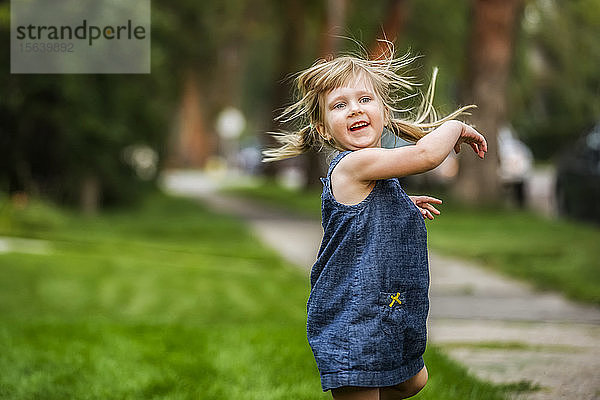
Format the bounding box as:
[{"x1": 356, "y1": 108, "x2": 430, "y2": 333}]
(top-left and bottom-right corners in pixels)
[{"x1": 336, "y1": 120, "x2": 487, "y2": 182}]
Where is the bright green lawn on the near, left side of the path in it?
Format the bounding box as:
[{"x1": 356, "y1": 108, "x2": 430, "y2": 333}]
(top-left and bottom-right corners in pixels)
[{"x1": 0, "y1": 195, "x2": 514, "y2": 400}]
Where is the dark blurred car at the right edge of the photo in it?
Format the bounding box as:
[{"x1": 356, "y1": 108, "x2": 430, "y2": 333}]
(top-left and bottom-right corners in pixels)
[{"x1": 556, "y1": 122, "x2": 600, "y2": 223}]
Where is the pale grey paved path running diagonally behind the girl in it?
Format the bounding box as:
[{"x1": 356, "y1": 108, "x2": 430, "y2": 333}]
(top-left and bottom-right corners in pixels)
[{"x1": 164, "y1": 173, "x2": 600, "y2": 400}]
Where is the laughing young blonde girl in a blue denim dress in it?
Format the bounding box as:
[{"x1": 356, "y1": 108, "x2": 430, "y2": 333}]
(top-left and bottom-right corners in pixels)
[{"x1": 264, "y1": 46, "x2": 487, "y2": 399}]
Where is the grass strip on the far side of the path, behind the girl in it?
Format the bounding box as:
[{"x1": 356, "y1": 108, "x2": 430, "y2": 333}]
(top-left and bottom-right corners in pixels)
[{"x1": 225, "y1": 183, "x2": 600, "y2": 305}]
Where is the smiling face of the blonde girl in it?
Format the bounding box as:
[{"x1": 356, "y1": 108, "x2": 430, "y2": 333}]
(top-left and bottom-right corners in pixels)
[{"x1": 317, "y1": 76, "x2": 384, "y2": 150}]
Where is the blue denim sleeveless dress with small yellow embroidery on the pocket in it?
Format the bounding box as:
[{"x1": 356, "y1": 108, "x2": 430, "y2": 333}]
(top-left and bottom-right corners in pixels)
[{"x1": 307, "y1": 151, "x2": 429, "y2": 391}]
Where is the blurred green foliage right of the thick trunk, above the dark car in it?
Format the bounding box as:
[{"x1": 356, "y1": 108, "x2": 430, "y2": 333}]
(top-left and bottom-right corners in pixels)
[{"x1": 510, "y1": 0, "x2": 600, "y2": 159}]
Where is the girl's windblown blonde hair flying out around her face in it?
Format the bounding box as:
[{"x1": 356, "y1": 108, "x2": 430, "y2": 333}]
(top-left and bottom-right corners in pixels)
[{"x1": 263, "y1": 42, "x2": 475, "y2": 162}]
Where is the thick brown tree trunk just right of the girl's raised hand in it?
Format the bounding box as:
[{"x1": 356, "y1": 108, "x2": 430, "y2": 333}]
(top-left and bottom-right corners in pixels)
[{"x1": 455, "y1": 0, "x2": 523, "y2": 203}]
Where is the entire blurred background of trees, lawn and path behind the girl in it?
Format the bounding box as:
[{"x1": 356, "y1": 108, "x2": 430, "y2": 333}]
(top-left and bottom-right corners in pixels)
[{"x1": 0, "y1": 0, "x2": 600, "y2": 400}]
